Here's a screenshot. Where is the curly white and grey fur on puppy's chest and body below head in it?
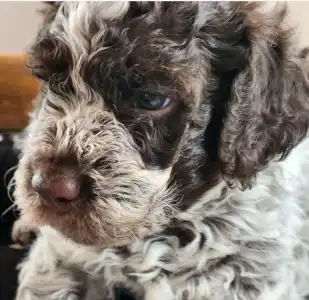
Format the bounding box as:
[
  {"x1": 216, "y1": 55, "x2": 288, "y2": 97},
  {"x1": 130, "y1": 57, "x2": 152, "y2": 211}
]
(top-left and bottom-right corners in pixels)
[{"x1": 33, "y1": 138, "x2": 309, "y2": 300}]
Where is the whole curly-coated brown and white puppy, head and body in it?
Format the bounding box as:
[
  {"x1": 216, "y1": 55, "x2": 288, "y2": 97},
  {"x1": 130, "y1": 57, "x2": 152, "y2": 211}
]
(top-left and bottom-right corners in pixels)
[{"x1": 15, "y1": 1, "x2": 309, "y2": 300}]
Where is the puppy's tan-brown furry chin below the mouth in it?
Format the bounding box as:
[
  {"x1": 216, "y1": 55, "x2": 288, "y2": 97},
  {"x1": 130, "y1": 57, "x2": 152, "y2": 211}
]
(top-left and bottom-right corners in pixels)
[{"x1": 18, "y1": 199, "x2": 166, "y2": 248}]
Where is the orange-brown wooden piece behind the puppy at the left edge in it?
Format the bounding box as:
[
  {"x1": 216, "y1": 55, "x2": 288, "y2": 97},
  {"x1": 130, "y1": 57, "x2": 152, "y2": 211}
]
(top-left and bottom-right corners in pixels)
[{"x1": 0, "y1": 54, "x2": 39, "y2": 132}]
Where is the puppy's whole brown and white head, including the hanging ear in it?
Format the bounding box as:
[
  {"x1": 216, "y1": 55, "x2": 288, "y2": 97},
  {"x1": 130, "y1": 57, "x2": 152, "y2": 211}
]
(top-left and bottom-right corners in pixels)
[{"x1": 15, "y1": 1, "x2": 309, "y2": 245}]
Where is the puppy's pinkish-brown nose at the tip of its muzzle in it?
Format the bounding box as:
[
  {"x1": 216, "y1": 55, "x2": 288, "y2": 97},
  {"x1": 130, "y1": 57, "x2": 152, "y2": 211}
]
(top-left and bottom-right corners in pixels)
[{"x1": 31, "y1": 173, "x2": 80, "y2": 202}]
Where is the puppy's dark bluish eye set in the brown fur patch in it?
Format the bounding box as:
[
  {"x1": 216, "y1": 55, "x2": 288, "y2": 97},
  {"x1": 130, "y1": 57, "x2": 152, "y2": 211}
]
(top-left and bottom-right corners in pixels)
[{"x1": 135, "y1": 93, "x2": 172, "y2": 110}]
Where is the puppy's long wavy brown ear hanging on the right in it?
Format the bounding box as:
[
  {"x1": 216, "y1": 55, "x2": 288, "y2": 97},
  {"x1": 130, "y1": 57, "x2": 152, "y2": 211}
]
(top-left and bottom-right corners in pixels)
[{"x1": 219, "y1": 4, "x2": 309, "y2": 184}]
